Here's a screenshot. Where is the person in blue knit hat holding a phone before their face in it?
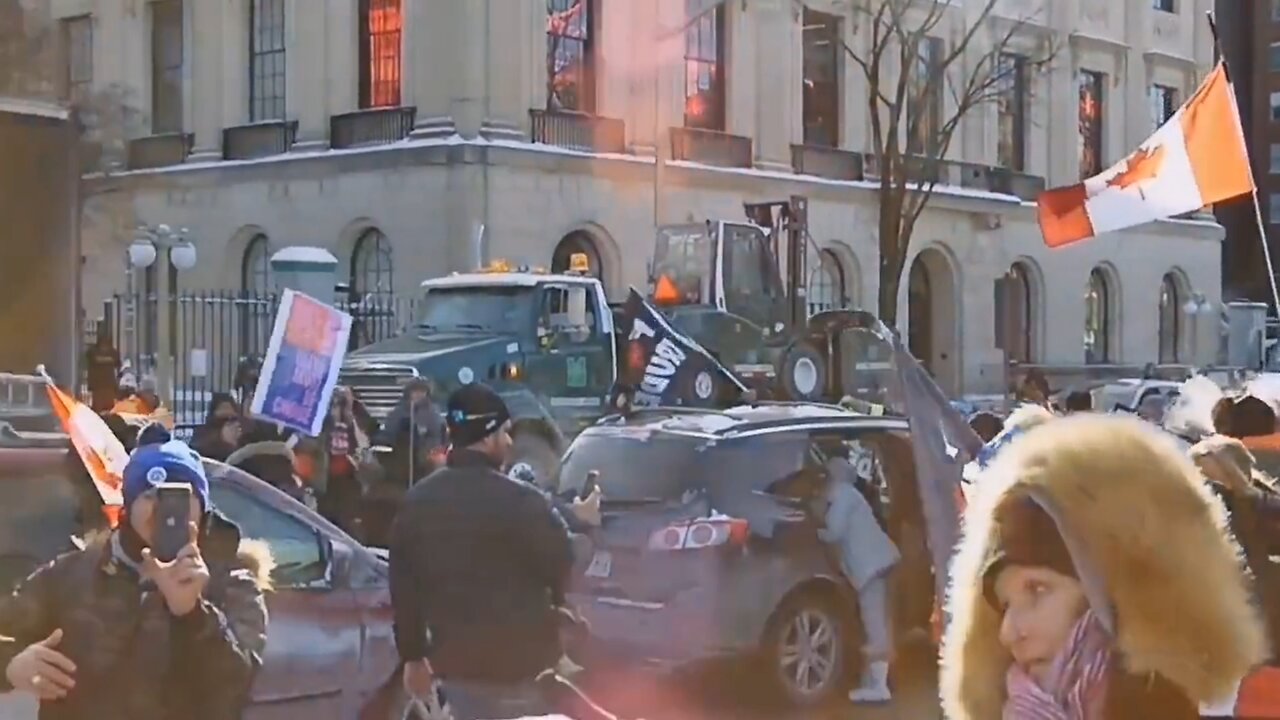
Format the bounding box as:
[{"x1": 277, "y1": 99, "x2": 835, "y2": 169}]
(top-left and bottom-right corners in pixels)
[{"x1": 0, "y1": 441, "x2": 271, "y2": 720}]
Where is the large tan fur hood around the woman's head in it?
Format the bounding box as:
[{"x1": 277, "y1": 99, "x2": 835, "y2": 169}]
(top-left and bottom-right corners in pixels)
[{"x1": 941, "y1": 414, "x2": 1266, "y2": 720}]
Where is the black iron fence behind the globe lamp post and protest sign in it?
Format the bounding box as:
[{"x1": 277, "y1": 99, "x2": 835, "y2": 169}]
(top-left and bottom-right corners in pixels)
[{"x1": 86, "y1": 285, "x2": 416, "y2": 424}]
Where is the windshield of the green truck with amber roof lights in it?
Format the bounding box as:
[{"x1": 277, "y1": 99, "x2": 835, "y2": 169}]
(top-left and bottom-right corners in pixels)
[{"x1": 417, "y1": 286, "x2": 536, "y2": 332}]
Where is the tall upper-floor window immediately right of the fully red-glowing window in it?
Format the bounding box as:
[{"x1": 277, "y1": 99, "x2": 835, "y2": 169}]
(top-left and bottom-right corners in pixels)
[{"x1": 547, "y1": 0, "x2": 595, "y2": 113}]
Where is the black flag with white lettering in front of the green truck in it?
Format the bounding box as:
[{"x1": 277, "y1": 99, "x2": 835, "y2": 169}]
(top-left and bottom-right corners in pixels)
[{"x1": 611, "y1": 288, "x2": 746, "y2": 409}]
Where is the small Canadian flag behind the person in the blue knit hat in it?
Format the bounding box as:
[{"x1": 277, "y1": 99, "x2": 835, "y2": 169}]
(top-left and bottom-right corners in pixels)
[{"x1": 45, "y1": 382, "x2": 129, "y2": 528}]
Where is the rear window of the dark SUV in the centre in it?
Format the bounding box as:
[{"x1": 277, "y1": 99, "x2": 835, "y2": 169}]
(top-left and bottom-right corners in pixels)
[{"x1": 559, "y1": 428, "x2": 707, "y2": 502}]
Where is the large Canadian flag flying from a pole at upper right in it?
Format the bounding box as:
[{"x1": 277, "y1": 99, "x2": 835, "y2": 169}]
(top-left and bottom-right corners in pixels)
[{"x1": 1038, "y1": 63, "x2": 1254, "y2": 247}]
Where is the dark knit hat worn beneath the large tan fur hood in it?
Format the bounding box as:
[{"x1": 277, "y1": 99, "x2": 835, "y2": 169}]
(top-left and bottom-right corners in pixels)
[{"x1": 982, "y1": 496, "x2": 1076, "y2": 609}]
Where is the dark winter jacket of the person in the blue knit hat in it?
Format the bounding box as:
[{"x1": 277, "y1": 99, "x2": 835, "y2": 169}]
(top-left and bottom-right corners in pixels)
[{"x1": 0, "y1": 518, "x2": 271, "y2": 720}]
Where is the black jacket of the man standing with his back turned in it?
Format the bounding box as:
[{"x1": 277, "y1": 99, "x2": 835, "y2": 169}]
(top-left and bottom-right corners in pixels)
[{"x1": 390, "y1": 450, "x2": 573, "y2": 684}]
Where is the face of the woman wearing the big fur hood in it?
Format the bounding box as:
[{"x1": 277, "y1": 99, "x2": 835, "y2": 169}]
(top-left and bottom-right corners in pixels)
[{"x1": 995, "y1": 565, "x2": 1088, "y2": 682}]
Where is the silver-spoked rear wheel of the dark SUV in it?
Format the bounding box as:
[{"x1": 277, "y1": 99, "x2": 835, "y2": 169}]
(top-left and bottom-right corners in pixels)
[{"x1": 763, "y1": 593, "x2": 850, "y2": 708}]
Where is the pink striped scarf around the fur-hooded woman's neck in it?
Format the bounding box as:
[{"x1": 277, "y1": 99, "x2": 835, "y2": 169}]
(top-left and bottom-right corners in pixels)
[{"x1": 1004, "y1": 610, "x2": 1111, "y2": 720}]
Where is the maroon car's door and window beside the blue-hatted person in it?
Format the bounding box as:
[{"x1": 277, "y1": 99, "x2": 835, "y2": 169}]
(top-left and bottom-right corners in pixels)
[{"x1": 212, "y1": 482, "x2": 362, "y2": 720}]
